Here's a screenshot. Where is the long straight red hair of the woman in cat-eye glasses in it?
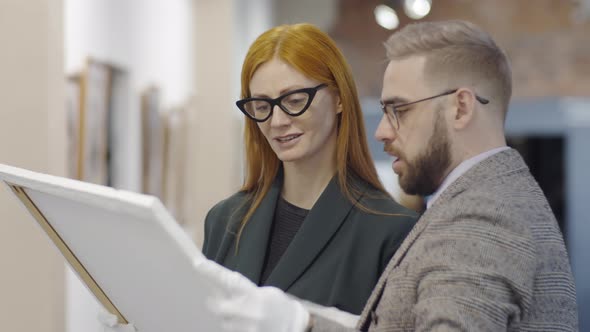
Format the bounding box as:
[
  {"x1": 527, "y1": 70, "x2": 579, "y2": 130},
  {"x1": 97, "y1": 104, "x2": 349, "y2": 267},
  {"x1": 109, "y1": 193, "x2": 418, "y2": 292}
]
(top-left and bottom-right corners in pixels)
[{"x1": 236, "y1": 23, "x2": 390, "y2": 243}]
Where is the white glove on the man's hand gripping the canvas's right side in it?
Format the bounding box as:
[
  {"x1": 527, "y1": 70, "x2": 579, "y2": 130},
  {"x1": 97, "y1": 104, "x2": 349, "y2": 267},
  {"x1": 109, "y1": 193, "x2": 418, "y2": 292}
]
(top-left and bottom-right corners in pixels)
[{"x1": 194, "y1": 258, "x2": 310, "y2": 332}]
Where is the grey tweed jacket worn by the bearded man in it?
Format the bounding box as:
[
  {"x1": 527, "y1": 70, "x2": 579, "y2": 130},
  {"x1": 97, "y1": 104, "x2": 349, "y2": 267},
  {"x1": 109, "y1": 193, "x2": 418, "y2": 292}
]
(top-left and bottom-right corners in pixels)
[{"x1": 313, "y1": 149, "x2": 578, "y2": 331}]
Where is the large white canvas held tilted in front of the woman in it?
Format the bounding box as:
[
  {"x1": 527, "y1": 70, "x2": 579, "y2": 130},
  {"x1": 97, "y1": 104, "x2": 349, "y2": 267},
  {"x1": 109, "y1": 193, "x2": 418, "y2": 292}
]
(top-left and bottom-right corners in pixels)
[{"x1": 0, "y1": 164, "x2": 225, "y2": 332}]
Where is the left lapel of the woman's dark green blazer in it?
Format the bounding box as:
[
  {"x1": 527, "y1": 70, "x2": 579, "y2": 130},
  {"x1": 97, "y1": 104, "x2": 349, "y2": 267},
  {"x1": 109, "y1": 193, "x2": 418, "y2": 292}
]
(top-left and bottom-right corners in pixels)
[{"x1": 229, "y1": 176, "x2": 282, "y2": 284}]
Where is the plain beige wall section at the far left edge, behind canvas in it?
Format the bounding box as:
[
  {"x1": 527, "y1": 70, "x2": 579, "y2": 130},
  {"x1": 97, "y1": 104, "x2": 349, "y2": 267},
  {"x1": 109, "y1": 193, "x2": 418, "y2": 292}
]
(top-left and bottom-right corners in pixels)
[{"x1": 0, "y1": 0, "x2": 66, "y2": 332}]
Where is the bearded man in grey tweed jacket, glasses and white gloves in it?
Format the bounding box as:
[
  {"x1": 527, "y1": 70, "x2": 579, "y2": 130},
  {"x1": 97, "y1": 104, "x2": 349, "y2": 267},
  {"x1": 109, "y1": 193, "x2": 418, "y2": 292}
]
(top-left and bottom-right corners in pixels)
[{"x1": 102, "y1": 21, "x2": 578, "y2": 331}]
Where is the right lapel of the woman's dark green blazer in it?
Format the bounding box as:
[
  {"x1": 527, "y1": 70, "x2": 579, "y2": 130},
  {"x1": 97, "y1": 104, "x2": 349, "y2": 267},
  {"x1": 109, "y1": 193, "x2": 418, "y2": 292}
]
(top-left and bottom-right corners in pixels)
[{"x1": 266, "y1": 176, "x2": 353, "y2": 290}]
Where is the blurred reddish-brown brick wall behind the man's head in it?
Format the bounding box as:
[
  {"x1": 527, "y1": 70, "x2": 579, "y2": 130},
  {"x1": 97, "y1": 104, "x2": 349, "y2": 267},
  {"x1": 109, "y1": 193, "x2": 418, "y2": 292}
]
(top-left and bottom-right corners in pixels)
[{"x1": 328, "y1": 0, "x2": 590, "y2": 98}]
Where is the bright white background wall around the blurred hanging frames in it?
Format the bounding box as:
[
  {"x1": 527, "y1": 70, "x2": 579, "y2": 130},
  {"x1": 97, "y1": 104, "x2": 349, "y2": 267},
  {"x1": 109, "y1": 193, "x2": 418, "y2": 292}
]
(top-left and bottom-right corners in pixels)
[{"x1": 64, "y1": 0, "x2": 195, "y2": 332}]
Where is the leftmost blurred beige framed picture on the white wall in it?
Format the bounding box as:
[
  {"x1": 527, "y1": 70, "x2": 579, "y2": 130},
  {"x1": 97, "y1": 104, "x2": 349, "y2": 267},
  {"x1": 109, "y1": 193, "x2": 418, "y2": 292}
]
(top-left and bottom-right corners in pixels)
[{"x1": 80, "y1": 59, "x2": 111, "y2": 185}]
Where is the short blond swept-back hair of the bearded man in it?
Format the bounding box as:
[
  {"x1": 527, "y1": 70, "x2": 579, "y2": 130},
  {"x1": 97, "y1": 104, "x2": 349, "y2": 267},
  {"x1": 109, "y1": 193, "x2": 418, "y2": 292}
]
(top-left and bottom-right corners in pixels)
[{"x1": 385, "y1": 20, "x2": 512, "y2": 117}]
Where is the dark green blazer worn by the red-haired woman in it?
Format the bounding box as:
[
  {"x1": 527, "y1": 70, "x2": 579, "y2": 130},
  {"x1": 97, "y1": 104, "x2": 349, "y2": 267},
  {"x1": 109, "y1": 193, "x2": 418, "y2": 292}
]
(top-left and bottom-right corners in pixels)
[{"x1": 203, "y1": 176, "x2": 417, "y2": 315}]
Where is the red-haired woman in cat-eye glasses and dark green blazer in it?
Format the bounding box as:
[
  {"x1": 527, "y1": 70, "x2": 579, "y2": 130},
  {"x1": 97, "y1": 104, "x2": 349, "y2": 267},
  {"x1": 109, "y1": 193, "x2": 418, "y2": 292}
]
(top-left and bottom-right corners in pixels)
[{"x1": 203, "y1": 24, "x2": 416, "y2": 314}]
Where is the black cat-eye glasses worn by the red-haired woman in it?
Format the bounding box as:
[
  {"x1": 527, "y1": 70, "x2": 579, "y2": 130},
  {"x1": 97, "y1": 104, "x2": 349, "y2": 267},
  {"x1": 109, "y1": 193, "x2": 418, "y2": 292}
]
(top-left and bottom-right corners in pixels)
[{"x1": 236, "y1": 83, "x2": 328, "y2": 122}]
